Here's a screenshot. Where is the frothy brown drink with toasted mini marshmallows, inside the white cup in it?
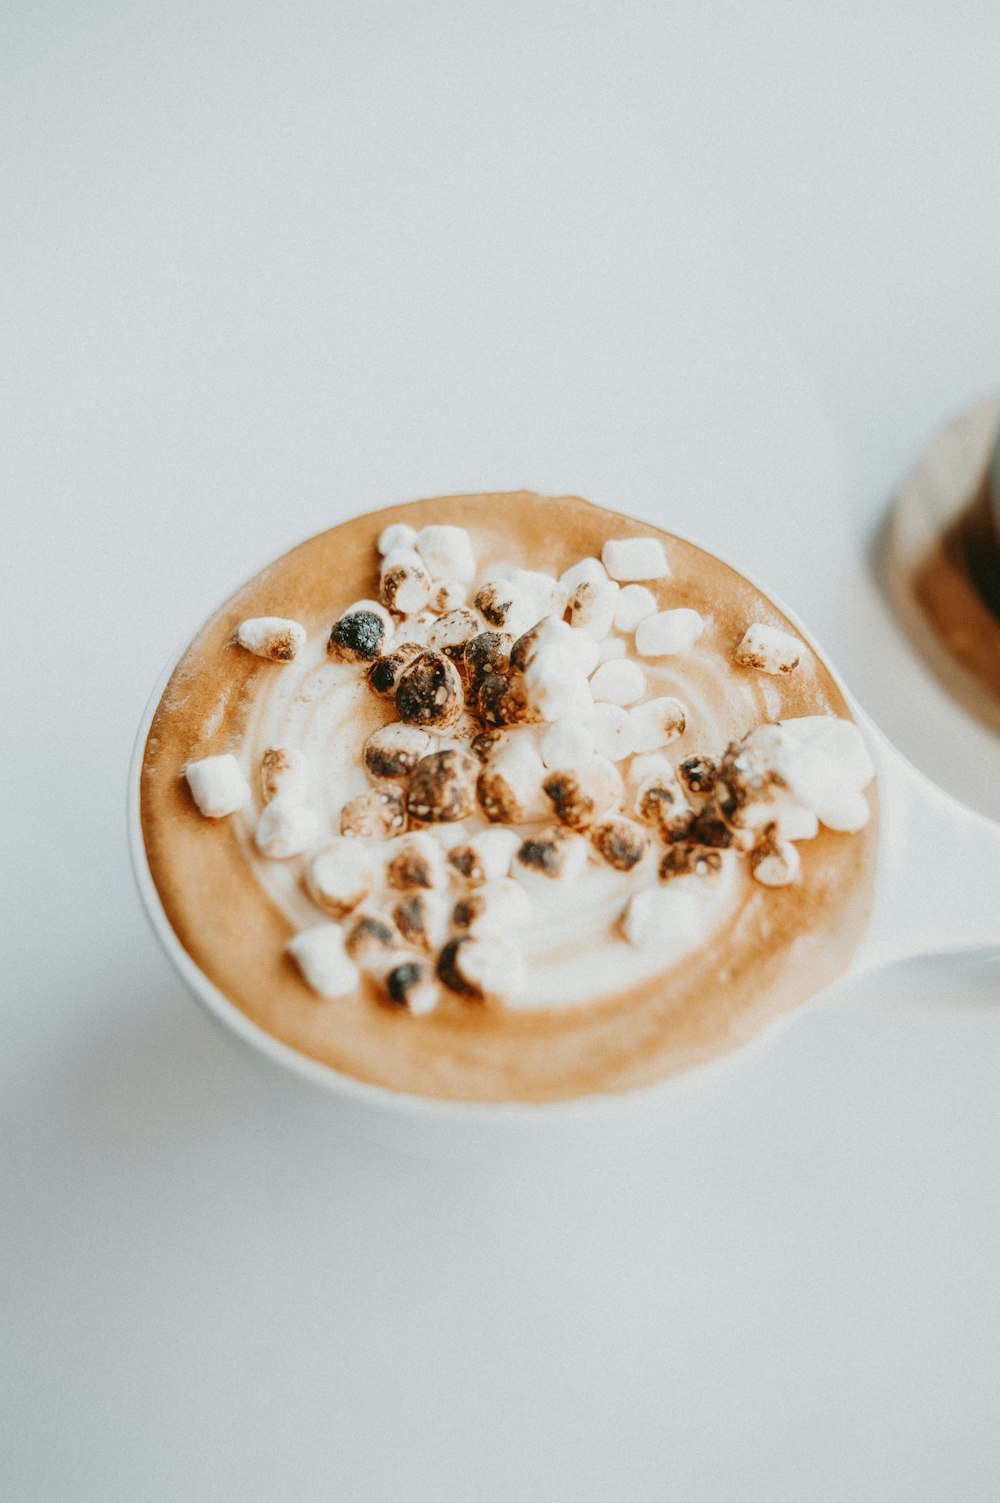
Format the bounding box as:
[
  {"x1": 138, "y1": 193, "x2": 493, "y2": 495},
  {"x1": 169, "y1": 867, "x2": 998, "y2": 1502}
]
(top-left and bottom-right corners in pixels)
[{"x1": 141, "y1": 491, "x2": 878, "y2": 1102}]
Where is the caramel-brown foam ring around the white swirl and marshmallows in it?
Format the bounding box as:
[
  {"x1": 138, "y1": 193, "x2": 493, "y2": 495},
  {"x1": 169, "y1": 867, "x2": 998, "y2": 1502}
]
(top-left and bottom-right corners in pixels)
[{"x1": 141, "y1": 491, "x2": 878, "y2": 1102}]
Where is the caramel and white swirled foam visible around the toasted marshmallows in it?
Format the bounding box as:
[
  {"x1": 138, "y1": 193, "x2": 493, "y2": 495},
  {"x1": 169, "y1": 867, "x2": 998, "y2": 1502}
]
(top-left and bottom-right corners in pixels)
[{"x1": 143, "y1": 493, "x2": 877, "y2": 1100}]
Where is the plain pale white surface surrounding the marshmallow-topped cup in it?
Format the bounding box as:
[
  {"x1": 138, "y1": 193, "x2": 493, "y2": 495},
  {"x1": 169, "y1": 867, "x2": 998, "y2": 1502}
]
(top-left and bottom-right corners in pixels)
[{"x1": 0, "y1": 0, "x2": 1000, "y2": 1503}]
